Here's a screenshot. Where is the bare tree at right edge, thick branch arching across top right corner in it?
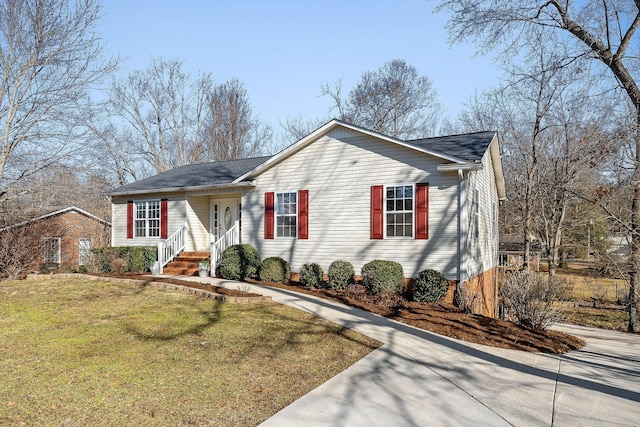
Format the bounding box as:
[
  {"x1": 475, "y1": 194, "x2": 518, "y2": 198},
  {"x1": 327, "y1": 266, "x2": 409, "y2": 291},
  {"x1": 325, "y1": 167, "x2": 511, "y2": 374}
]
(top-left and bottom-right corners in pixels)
[{"x1": 440, "y1": 0, "x2": 640, "y2": 332}]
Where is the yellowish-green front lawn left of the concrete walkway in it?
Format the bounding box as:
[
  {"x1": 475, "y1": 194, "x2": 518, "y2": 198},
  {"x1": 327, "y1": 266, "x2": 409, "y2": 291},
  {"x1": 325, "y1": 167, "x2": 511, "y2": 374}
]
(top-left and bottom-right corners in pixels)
[{"x1": 0, "y1": 279, "x2": 379, "y2": 426}]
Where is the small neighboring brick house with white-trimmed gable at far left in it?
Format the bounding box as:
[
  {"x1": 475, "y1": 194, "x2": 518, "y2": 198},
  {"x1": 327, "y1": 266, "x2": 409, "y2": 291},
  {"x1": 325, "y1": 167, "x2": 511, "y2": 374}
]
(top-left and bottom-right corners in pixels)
[{"x1": 0, "y1": 206, "x2": 111, "y2": 270}]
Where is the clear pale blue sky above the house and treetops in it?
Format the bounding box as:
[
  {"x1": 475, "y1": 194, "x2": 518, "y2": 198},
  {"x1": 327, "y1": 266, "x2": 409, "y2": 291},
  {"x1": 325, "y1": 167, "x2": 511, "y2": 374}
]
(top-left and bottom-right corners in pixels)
[{"x1": 98, "y1": 0, "x2": 500, "y2": 130}]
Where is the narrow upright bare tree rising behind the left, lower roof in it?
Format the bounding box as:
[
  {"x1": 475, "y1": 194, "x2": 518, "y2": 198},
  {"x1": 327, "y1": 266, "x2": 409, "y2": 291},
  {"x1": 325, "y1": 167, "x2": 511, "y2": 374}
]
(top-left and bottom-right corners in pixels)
[{"x1": 202, "y1": 79, "x2": 272, "y2": 161}]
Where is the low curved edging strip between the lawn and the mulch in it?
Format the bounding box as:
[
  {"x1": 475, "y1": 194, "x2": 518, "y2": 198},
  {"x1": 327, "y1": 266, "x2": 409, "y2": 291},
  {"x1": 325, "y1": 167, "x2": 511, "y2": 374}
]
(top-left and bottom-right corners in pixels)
[{"x1": 27, "y1": 273, "x2": 272, "y2": 304}]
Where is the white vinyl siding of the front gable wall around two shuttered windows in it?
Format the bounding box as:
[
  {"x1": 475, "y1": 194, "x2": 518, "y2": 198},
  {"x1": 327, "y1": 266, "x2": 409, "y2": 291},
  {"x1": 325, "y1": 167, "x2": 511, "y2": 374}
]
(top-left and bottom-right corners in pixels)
[{"x1": 242, "y1": 127, "x2": 458, "y2": 279}]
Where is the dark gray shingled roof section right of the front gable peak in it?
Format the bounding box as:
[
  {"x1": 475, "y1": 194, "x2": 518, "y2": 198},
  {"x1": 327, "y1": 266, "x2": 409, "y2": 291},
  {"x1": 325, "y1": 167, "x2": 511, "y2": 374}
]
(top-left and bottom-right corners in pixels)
[{"x1": 406, "y1": 131, "x2": 495, "y2": 162}]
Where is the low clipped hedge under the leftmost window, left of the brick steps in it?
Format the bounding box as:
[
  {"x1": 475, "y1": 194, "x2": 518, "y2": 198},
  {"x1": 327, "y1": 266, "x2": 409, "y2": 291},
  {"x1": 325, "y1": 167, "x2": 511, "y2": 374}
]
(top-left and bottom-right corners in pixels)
[{"x1": 91, "y1": 246, "x2": 158, "y2": 273}]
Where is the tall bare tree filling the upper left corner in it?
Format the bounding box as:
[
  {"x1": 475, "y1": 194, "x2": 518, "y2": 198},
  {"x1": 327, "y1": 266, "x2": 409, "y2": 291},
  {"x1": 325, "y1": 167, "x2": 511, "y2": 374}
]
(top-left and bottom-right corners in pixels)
[{"x1": 0, "y1": 0, "x2": 118, "y2": 207}]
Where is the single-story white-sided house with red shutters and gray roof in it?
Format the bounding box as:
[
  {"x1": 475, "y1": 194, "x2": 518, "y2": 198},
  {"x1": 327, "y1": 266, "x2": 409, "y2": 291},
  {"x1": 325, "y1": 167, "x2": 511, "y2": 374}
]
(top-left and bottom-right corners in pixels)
[{"x1": 111, "y1": 120, "x2": 505, "y2": 315}]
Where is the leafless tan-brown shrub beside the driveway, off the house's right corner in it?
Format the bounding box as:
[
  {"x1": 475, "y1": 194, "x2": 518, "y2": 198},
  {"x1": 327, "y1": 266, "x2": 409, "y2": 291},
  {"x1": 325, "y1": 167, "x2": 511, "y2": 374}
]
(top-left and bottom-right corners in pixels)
[{"x1": 500, "y1": 271, "x2": 572, "y2": 329}]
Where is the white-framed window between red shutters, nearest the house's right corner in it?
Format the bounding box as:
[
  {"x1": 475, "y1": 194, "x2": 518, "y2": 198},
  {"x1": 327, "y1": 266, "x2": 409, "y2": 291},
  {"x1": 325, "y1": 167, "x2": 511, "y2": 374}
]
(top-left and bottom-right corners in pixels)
[{"x1": 385, "y1": 184, "x2": 414, "y2": 238}]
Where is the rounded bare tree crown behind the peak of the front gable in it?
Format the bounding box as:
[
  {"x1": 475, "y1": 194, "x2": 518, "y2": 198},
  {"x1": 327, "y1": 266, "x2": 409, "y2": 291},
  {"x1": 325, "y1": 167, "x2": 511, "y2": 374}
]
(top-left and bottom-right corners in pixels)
[{"x1": 321, "y1": 59, "x2": 442, "y2": 139}]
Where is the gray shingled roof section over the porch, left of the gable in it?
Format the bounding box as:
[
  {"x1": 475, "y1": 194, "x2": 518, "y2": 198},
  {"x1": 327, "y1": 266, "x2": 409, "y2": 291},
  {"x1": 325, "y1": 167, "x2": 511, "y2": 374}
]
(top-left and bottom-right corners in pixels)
[{"x1": 111, "y1": 156, "x2": 271, "y2": 195}]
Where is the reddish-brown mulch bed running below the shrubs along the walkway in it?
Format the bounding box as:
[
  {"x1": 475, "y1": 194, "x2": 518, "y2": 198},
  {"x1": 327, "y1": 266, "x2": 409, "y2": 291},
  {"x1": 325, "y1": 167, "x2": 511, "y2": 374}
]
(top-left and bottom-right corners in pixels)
[{"x1": 94, "y1": 274, "x2": 585, "y2": 354}]
